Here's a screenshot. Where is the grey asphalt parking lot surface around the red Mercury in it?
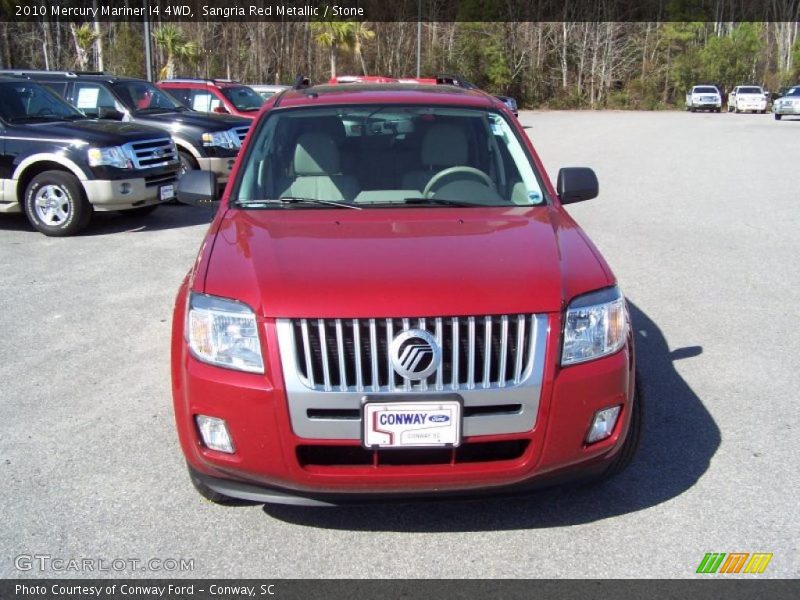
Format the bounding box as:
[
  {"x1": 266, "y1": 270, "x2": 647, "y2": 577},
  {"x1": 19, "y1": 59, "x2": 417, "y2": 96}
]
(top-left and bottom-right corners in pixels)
[{"x1": 0, "y1": 112, "x2": 800, "y2": 578}]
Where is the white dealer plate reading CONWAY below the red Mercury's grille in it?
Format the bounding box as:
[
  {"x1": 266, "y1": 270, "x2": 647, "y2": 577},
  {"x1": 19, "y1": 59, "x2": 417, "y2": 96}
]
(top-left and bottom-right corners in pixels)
[{"x1": 361, "y1": 399, "x2": 462, "y2": 448}]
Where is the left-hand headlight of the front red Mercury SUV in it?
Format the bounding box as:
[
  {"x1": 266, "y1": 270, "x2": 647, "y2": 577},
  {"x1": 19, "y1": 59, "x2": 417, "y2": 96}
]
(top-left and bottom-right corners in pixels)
[{"x1": 186, "y1": 293, "x2": 264, "y2": 373}]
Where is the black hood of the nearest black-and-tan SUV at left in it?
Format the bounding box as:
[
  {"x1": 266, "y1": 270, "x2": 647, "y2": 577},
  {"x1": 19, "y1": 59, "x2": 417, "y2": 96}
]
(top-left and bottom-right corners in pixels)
[{"x1": 14, "y1": 119, "x2": 170, "y2": 146}]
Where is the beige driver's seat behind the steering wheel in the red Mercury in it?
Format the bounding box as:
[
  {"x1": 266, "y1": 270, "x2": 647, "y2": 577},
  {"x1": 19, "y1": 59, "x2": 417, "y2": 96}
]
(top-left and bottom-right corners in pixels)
[{"x1": 403, "y1": 123, "x2": 469, "y2": 192}]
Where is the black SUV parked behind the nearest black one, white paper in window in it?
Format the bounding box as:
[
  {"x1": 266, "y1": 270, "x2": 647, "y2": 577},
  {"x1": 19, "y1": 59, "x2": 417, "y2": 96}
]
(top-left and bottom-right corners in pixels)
[{"x1": 5, "y1": 70, "x2": 251, "y2": 183}]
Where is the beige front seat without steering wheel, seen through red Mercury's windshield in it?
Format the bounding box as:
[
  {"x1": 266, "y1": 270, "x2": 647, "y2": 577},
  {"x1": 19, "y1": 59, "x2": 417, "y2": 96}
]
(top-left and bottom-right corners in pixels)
[{"x1": 278, "y1": 132, "x2": 359, "y2": 202}]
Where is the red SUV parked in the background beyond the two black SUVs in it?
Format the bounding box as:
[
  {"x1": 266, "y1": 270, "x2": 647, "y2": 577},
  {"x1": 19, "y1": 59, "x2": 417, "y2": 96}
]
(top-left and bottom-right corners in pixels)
[{"x1": 156, "y1": 79, "x2": 264, "y2": 119}]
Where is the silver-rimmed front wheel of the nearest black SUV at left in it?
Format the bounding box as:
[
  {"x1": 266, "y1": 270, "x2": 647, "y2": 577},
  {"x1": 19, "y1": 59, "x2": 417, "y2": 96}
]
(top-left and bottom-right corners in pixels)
[{"x1": 23, "y1": 171, "x2": 92, "y2": 237}]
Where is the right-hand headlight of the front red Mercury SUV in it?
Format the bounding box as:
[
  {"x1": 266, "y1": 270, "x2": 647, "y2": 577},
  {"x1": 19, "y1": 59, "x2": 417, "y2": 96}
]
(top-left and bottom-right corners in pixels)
[{"x1": 561, "y1": 287, "x2": 628, "y2": 366}]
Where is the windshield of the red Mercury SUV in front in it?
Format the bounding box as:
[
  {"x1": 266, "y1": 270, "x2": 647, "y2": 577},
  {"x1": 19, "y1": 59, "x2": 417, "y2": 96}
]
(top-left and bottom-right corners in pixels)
[{"x1": 231, "y1": 105, "x2": 544, "y2": 208}]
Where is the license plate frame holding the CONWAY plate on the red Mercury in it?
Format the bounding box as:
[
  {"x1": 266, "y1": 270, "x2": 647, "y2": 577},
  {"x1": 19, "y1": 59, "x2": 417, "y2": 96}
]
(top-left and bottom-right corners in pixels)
[{"x1": 361, "y1": 394, "x2": 464, "y2": 450}]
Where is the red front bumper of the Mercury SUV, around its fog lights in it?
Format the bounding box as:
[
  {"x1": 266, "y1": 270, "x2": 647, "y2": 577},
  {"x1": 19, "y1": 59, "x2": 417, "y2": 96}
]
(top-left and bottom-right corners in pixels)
[{"x1": 172, "y1": 288, "x2": 634, "y2": 504}]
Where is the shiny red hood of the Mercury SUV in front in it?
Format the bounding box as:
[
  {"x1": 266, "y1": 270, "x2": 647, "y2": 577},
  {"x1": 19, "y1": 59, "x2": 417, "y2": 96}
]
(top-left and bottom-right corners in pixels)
[{"x1": 202, "y1": 207, "x2": 612, "y2": 318}]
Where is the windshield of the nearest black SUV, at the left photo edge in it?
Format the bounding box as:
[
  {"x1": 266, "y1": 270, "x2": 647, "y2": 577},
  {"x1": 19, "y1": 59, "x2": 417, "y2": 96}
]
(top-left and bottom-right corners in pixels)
[{"x1": 0, "y1": 81, "x2": 86, "y2": 123}]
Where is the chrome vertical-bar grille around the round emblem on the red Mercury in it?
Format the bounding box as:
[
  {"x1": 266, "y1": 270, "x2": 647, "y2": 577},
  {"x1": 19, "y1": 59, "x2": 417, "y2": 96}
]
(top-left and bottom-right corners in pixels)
[{"x1": 292, "y1": 315, "x2": 534, "y2": 392}]
